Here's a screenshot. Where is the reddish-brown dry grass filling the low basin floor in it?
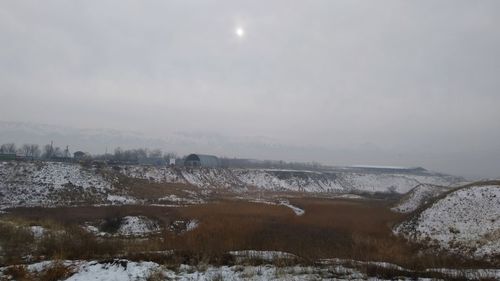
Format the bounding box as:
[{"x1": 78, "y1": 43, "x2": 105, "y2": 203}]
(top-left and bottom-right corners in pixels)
[{"x1": 0, "y1": 198, "x2": 492, "y2": 268}]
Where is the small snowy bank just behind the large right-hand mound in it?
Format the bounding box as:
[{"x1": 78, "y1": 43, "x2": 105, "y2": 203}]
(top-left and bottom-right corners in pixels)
[{"x1": 391, "y1": 184, "x2": 450, "y2": 213}]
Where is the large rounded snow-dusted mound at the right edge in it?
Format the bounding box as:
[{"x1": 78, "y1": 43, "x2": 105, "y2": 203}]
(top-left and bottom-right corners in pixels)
[{"x1": 394, "y1": 185, "x2": 500, "y2": 258}]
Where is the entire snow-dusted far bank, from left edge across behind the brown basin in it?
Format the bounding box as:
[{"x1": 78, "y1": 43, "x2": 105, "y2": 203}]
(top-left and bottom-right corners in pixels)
[{"x1": 0, "y1": 161, "x2": 457, "y2": 208}]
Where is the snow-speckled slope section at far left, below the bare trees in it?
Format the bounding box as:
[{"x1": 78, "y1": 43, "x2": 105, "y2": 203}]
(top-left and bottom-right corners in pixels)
[{"x1": 0, "y1": 161, "x2": 112, "y2": 208}]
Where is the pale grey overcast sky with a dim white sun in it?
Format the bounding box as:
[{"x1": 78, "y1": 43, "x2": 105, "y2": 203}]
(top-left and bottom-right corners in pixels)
[{"x1": 0, "y1": 0, "x2": 500, "y2": 177}]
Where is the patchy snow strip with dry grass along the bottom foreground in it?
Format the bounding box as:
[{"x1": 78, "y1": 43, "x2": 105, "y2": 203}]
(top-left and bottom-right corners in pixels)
[{"x1": 0, "y1": 259, "x2": 500, "y2": 281}]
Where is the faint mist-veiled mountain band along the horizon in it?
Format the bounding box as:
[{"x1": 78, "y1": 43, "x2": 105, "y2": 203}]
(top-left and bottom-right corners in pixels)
[{"x1": 0, "y1": 121, "x2": 500, "y2": 178}]
